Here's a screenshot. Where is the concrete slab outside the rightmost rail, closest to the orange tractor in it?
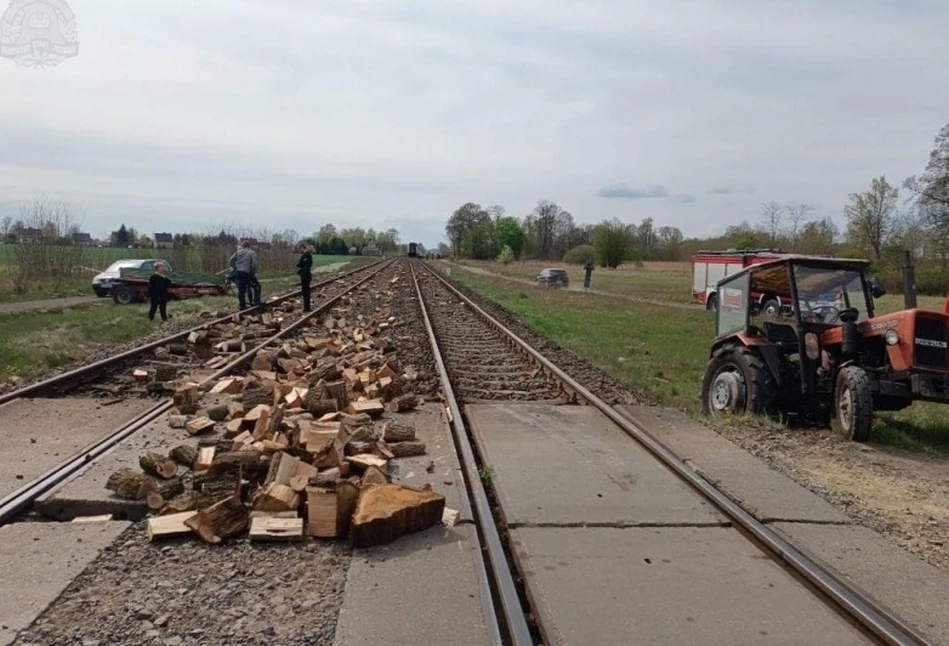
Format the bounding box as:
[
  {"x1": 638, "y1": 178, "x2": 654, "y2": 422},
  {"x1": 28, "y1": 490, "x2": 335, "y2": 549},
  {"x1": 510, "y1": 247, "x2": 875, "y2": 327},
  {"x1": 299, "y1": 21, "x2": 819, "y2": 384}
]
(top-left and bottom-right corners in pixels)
[{"x1": 616, "y1": 406, "x2": 850, "y2": 523}]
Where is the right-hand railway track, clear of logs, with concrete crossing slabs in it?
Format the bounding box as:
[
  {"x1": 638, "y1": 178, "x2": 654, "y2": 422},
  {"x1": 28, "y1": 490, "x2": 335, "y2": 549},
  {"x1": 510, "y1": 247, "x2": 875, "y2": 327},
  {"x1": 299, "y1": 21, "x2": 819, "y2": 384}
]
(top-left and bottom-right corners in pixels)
[{"x1": 412, "y1": 261, "x2": 929, "y2": 646}]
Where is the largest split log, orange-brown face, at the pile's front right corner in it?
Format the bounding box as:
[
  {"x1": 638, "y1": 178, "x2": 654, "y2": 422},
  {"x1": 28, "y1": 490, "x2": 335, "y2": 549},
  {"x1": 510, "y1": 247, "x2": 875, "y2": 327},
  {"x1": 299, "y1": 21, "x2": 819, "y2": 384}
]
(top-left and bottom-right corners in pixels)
[{"x1": 349, "y1": 484, "x2": 445, "y2": 547}]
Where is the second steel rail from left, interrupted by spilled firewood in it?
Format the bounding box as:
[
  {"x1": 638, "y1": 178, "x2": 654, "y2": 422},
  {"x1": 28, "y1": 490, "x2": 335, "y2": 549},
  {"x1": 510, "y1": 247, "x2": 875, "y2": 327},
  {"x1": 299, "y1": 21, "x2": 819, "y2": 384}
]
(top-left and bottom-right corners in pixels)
[{"x1": 0, "y1": 259, "x2": 394, "y2": 526}]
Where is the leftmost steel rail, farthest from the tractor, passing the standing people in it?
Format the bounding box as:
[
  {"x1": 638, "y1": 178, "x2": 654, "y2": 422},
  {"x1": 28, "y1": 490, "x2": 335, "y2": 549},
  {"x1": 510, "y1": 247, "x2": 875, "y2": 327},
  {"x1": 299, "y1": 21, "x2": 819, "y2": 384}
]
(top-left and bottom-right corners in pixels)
[{"x1": 0, "y1": 260, "x2": 387, "y2": 405}]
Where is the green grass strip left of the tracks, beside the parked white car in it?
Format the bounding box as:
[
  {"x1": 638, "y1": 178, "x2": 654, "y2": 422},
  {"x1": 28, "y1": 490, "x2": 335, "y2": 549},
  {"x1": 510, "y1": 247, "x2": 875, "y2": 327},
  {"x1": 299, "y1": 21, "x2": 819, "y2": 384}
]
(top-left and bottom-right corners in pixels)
[{"x1": 0, "y1": 297, "x2": 234, "y2": 380}]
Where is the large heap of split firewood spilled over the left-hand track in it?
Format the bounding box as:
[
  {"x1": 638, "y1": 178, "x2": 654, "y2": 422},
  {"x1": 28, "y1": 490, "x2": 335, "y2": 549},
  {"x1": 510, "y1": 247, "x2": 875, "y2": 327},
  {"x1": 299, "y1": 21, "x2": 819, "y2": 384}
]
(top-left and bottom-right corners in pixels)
[{"x1": 106, "y1": 275, "x2": 457, "y2": 547}]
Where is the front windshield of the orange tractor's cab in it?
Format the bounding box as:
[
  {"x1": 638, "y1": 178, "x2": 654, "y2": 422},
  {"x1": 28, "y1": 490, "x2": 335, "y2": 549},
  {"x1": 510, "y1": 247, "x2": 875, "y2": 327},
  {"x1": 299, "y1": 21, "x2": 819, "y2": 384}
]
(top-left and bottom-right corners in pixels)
[{"x1": 794, "y1": 265, "x2": 870, "y2": 323}]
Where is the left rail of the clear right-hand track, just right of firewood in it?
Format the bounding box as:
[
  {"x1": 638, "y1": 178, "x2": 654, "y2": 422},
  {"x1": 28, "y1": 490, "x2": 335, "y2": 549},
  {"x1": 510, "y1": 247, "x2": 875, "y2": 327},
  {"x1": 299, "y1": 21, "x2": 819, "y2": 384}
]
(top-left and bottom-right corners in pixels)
[{"x1": 412, "y1": 267, "x2": 534, "y2": 646}]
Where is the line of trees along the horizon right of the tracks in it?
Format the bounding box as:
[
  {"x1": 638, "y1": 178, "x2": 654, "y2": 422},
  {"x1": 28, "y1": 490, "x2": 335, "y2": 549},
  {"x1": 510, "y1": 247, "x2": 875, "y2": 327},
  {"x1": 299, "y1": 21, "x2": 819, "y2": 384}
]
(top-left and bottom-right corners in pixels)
[{"x1": 445, "y1": 124, "x2": 949, "y2": 294}]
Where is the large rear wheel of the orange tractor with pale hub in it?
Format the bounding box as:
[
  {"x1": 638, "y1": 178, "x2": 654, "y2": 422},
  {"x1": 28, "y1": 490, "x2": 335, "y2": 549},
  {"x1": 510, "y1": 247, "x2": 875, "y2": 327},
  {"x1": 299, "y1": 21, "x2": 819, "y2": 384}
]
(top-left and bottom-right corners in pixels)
[{"x1": 702, "y1": 346, "x2": 777, "y2": 416}]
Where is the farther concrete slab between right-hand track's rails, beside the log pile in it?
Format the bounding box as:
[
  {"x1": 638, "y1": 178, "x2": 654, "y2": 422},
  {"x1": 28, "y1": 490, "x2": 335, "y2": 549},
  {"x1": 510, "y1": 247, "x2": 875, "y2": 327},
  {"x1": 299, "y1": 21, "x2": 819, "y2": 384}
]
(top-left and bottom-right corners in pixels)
[{"x1": 465, "y1": 403, "x2": 726, "y2": 527}]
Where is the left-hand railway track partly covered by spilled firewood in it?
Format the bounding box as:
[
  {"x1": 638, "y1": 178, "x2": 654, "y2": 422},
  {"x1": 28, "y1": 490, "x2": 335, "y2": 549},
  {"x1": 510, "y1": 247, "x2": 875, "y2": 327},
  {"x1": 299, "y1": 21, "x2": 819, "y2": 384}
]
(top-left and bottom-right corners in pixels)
[{"x1": 0, "y1": 260, "x2": 393, "y2": 526}]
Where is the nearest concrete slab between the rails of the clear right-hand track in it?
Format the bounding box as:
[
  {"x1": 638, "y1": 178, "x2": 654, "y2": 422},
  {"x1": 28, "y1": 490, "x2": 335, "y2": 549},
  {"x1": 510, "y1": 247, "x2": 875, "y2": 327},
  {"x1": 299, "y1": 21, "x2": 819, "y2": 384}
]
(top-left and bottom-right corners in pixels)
[{"x1": 511, "y1": 527, "x2": 873, "y2": 646}]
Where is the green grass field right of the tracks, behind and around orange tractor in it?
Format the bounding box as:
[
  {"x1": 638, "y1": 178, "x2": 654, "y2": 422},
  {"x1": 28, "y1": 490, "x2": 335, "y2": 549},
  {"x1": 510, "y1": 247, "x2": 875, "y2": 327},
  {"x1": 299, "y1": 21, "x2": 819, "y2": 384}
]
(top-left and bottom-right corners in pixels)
[{"x1": 452, "y1": 271, "x2": 949, "y2": 453}]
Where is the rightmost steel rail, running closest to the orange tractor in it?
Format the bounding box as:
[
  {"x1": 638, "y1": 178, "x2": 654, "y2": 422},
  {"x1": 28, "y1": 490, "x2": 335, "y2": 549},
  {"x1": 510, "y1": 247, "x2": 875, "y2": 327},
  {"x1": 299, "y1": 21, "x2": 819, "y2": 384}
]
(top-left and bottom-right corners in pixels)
[{"x1": 423, "y1": 263, "x2": 931, "y2": 646}]
